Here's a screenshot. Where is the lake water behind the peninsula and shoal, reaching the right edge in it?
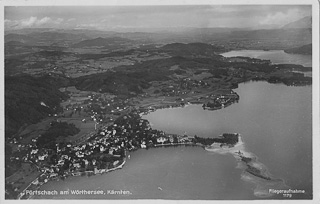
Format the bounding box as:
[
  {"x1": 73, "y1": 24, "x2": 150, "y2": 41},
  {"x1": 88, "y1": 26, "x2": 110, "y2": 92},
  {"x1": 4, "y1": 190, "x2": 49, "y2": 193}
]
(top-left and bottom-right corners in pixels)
[{"x1": 145, "y1": 82, "x2": 312, "y2": 198}]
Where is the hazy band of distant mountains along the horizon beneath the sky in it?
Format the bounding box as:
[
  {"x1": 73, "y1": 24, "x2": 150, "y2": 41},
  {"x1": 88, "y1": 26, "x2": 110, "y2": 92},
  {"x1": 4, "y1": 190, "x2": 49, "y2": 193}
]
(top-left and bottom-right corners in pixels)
[{"x1": 5, "y1": 16, "x2": 312, "y2": 50}]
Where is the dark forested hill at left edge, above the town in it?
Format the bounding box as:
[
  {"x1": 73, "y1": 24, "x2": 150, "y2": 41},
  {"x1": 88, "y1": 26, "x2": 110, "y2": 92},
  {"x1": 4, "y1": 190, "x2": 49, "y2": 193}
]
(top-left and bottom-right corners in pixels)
[{"x1": 5, "y1": 75, "x2": 67, "y2": 138}]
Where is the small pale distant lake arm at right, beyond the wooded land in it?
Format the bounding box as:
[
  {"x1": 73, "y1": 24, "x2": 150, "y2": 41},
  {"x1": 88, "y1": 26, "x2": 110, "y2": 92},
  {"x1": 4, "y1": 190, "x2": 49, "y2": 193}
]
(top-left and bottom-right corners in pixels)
[{"x1": 221, "y1": 50, "x2": 312, "y2": 67}]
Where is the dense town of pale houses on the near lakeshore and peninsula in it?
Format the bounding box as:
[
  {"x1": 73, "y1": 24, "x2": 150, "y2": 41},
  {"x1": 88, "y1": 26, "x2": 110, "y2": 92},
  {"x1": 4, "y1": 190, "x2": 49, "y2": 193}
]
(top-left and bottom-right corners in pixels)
[{"x1": 15, "y1": 111, "x2": 198, "y2": 198}]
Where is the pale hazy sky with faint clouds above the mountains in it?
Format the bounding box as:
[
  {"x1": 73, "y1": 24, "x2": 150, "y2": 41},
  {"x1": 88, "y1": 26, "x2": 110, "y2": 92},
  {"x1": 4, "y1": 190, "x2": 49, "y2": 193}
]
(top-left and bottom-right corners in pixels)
[{"x1": 4, "y1": 5, "x2": 311, "y2": 30}]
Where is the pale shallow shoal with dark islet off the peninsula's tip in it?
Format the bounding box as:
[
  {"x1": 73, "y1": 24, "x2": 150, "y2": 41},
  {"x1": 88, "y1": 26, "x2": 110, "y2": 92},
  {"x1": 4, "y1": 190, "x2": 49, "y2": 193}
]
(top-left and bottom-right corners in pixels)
[{"x1": 205, "y1": 134, "x2": 290, "y2": 198}]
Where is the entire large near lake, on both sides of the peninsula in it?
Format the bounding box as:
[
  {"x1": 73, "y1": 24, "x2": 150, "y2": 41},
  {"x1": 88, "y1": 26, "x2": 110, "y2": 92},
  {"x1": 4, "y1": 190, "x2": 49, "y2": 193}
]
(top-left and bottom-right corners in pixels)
[{"x1": 36, "y1": 82, "x2": 312, "y2": 200}]
